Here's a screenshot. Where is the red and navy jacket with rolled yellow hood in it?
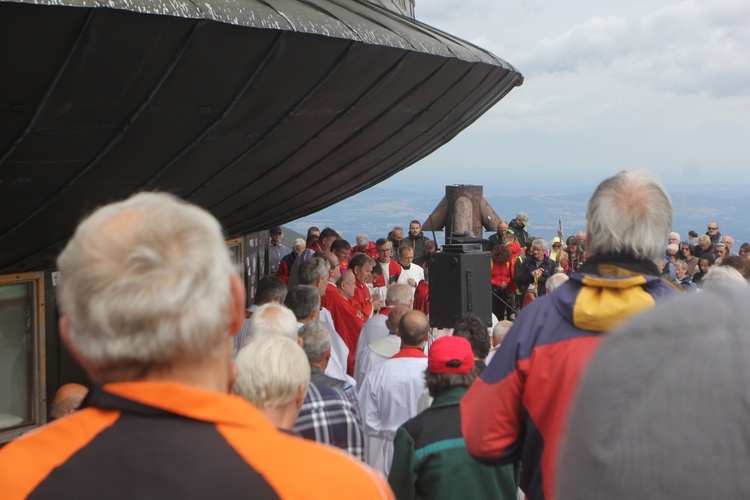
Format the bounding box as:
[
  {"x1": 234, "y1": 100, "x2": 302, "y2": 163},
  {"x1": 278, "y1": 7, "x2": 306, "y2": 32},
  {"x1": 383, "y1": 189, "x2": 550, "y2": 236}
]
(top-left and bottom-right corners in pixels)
[{"x1": 461, "y1": 263, "x2": 677, "y2": 499}]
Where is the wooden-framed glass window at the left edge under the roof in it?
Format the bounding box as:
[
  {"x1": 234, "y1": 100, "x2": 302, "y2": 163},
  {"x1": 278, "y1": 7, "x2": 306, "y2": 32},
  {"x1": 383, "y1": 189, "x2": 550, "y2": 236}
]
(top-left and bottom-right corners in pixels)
[{"x1": 0, "y1": 273, "x2": 45, "y2": 442}]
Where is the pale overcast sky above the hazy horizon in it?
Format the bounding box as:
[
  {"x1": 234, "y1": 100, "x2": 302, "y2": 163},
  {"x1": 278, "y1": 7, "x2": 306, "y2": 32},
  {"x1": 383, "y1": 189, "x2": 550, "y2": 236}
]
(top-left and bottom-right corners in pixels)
[{"x1": 381, "y1": 0, "x2": 750, "y2": 193}]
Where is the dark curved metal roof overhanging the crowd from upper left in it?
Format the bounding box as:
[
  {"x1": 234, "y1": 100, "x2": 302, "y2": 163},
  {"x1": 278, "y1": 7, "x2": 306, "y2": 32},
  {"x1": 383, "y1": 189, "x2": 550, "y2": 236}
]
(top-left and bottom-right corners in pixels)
[{"x1": 0, "y1": 0, "x2": 523, "y2": 271}]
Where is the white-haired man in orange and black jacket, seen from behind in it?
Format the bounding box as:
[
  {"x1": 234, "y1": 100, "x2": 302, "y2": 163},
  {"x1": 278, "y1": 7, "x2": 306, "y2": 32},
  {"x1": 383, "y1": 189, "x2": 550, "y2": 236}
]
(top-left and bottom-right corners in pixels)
[{"x1": 0, "y1": 193, "x2": 389, "y2": 499}]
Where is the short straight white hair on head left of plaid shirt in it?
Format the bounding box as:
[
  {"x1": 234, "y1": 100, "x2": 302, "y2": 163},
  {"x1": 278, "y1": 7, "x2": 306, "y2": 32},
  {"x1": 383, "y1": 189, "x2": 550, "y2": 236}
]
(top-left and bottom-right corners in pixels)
[{"x1": 234, "y1": 335, "x2": 310, "y2": 409}]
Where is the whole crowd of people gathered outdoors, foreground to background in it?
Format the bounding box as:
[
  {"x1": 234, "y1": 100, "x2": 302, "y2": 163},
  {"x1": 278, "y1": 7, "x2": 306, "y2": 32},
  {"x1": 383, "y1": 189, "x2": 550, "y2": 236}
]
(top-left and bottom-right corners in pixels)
[{"x1": 0, "y1": 170, "x2": 750, "y2": 499}]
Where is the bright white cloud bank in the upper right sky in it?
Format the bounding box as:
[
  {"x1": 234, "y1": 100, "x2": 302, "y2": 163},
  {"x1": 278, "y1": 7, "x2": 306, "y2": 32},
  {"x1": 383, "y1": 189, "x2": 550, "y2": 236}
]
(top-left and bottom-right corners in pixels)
[{"x1": 508, "y1": 0, "x2": 750, "y2": 96}]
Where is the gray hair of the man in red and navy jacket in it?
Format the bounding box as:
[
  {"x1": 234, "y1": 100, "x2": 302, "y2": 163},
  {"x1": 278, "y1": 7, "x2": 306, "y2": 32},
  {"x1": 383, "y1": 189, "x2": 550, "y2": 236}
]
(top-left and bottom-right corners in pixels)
[{"x1": 586, "y1": 170, "x2": 672, "y2": 263}]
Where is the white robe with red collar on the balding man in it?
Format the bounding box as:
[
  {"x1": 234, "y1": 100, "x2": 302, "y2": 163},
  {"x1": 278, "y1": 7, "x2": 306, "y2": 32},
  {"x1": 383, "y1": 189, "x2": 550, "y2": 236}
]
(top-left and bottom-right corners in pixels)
[{"x1": 359, "y1": 357, "x2": 427, "y2": 477}]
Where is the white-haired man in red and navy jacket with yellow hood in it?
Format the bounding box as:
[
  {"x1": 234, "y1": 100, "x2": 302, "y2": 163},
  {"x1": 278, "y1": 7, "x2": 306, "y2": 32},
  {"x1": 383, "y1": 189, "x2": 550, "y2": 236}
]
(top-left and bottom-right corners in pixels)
[{"x1": 461, "y1": 170, "x2": 677, "y2": 500}]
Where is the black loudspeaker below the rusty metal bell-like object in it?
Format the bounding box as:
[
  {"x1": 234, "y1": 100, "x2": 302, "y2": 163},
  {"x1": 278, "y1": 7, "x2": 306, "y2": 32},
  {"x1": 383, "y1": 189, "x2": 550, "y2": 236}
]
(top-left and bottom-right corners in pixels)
[{"x1": 429, "y1": 252, "x2": 492, "y2": 328}]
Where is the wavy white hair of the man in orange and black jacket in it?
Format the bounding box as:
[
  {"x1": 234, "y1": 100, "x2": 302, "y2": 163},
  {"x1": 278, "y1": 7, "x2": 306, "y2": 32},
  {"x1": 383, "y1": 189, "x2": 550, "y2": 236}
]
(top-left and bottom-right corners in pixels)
[{"x1": 57, "y1": 193, "x2": 235, "y2": 382}]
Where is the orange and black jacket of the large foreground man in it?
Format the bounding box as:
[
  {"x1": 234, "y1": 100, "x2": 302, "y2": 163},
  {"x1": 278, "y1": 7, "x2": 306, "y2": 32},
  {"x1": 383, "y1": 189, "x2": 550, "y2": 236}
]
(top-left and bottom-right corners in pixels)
[{"x1": 0, "y1": 382, "x2": 391, "y2": 499}]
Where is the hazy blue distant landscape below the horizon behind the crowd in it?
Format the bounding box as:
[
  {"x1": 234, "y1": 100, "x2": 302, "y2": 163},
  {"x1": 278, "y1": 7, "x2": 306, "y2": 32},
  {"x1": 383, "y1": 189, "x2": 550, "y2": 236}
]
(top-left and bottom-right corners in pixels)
[{"x1": 286, "y1": 186, "x2": 750, "y2": 246}]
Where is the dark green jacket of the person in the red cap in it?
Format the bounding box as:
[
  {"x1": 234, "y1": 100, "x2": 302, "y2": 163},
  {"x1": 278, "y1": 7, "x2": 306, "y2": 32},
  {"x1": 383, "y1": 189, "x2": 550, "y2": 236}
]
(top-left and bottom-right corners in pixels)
[{"x1": 388, "y1": 387, "x2": 518, "y2": 500}]
